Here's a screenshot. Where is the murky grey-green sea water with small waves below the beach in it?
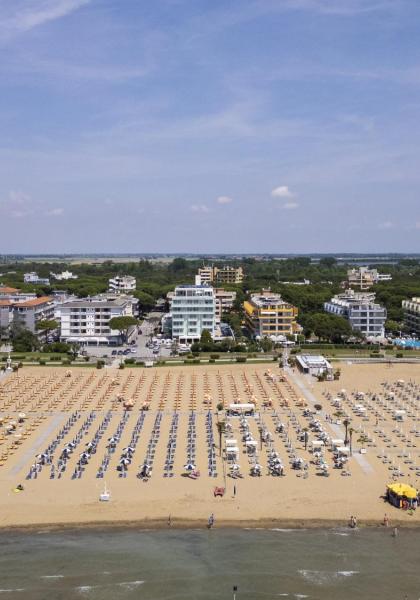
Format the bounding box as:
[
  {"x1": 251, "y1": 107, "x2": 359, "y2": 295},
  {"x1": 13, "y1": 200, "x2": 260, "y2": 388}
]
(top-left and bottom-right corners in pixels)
[{"x1": 0, "y1": 527, "x2": 420, "y2": 600}]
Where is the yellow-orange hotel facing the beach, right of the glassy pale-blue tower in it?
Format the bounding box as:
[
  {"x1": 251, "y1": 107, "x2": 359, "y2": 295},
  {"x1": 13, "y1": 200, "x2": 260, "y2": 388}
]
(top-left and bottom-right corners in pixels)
[{"x1": 244, "y1": 290, "x2": 300, "y2": 337}]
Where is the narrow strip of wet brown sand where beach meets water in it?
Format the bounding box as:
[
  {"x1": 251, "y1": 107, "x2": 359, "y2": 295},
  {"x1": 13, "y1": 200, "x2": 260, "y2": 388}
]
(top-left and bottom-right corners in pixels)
[{"x1": 0, "y1": 516, "x2": 420, "y2": 535}]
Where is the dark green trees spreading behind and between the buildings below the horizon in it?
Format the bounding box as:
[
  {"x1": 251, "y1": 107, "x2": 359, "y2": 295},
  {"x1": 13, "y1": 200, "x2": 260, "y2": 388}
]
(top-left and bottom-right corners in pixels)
[{"x1": 0, "y1": 257, "x2": 420, "y2": 328}]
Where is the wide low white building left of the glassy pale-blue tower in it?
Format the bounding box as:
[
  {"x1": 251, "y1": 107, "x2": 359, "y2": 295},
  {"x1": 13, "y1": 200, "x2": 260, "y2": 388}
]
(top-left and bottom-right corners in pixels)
[{"x1": 58, "y1": 296, "x2": 133, "y2": 345}]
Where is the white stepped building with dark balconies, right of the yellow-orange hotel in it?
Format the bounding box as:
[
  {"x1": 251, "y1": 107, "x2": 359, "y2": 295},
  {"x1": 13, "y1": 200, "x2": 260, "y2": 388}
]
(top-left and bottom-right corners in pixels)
[{"x1": 324, "y1": 290, "x2": 387, "y2": 337}]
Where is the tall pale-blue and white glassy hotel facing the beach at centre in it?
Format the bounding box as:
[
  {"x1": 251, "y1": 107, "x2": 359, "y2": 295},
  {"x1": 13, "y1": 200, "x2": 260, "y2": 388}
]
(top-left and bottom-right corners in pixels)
[{"x1": 171, "y1": 284, "x2": 216, "y2": 343}]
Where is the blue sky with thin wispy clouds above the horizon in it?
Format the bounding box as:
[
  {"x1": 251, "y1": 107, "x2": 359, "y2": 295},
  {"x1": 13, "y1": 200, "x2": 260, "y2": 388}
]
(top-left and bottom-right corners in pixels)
[{"x1": 0, "y1": 0, "x2": 420, "y2": 253}]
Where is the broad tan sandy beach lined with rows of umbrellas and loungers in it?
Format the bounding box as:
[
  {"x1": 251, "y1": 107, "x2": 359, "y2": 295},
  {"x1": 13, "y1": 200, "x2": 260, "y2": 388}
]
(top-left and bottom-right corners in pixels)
[{"x1": 0, "y1": 363, "x2": 420, "y2": 528}]
